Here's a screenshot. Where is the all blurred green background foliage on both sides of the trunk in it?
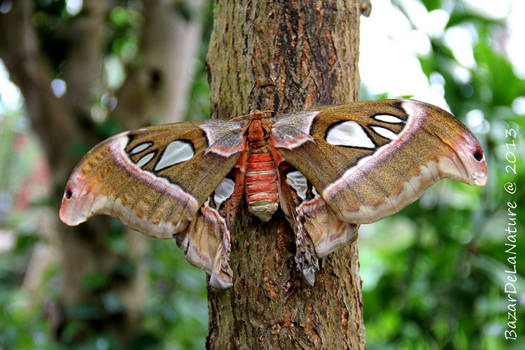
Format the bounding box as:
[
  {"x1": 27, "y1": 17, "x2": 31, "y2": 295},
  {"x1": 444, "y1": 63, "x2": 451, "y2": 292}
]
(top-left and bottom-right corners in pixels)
[{"x1": 0, "y1": 0, "x2": 525, "y2": 350}]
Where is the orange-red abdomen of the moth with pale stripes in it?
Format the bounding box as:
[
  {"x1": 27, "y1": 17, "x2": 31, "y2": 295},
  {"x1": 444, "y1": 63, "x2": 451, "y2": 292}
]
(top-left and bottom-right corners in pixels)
[{"x1": 246, "y1": 147, "x2": 279, "y2": 221}]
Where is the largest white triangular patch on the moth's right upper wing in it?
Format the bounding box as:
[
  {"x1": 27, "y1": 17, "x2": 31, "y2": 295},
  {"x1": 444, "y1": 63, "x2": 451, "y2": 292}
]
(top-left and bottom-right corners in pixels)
[{"x1": 326, "y1": 120, "x2": 376, "y2": 148}]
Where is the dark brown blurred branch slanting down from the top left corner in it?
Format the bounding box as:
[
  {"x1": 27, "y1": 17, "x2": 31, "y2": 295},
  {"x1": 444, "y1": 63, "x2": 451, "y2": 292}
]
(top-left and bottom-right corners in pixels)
[{"x1": 0, "y1": 1, "x2": 82, "y2": 176}]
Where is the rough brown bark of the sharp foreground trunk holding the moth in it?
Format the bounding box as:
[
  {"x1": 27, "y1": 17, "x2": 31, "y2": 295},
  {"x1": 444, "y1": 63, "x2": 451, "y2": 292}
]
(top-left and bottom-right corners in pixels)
[{"x1": 207, "y1": 0, "x2": 365, "y2": 349}]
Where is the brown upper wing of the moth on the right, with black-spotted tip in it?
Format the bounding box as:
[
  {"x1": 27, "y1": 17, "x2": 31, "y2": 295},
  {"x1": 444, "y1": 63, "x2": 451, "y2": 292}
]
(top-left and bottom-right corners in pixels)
[{"x1": 271, "y1": 100, "x2": 487, "y2": 224}]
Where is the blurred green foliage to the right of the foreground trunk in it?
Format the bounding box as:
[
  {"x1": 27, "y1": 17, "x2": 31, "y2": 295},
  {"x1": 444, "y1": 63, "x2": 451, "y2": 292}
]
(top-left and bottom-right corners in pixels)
[{"x1": 360, "y1": 0, "x2": 525, "y2": 350}]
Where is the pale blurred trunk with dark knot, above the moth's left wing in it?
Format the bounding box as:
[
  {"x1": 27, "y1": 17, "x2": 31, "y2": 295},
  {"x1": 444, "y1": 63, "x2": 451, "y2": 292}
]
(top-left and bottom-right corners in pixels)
[{"x1": 113, "y1": 0, "x2": 203, "y2": 129}]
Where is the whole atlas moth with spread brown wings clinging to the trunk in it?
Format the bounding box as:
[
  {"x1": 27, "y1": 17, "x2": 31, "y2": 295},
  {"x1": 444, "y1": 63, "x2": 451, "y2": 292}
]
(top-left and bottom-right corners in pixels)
[{"x1": 60, "y1": 100, "x2": 487, "y2": 288}]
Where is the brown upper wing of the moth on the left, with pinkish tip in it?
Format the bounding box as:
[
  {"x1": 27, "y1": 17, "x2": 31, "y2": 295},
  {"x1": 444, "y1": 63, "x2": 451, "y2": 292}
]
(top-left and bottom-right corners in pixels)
[{"x1": 60, "y1": 121, "x2": 245, "y2": 238}]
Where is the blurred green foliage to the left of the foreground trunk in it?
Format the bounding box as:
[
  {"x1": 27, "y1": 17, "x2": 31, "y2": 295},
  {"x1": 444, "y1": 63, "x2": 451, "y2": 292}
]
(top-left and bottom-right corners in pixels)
[{"x1": 0, "y1": 0, "x2": 212, "y2": 350}]
